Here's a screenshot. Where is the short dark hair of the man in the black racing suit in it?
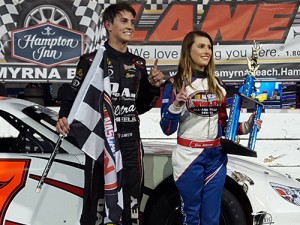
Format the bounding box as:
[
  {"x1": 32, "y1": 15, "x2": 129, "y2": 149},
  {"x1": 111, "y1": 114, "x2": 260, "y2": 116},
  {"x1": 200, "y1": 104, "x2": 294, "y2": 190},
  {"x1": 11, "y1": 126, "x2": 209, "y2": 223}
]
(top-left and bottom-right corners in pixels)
[{"x1": 102, "y1": 2, "x2": 136, "y2": 23}]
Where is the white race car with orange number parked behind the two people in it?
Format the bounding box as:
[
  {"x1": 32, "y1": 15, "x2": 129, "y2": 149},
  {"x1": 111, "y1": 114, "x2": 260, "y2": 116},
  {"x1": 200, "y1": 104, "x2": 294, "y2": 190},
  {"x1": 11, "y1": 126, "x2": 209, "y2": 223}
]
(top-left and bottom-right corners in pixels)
[{"x1": 0, "y1": 97, "x2": 300, "y2": 225}]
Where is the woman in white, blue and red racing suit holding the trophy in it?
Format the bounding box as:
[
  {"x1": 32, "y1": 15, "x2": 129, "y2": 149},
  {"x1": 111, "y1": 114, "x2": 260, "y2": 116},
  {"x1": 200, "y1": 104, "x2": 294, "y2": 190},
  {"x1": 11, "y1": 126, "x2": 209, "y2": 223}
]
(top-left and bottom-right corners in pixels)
[{"x1": 160, "y1": 31, "x2": 262, "y2": 225}]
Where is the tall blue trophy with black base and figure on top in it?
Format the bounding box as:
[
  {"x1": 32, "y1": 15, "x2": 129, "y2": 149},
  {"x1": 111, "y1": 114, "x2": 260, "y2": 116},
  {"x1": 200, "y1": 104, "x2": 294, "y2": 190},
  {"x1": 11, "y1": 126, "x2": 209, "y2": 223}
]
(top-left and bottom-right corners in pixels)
[{"x1": 221, "y1": 41, "x2": 264, "y2": 157}]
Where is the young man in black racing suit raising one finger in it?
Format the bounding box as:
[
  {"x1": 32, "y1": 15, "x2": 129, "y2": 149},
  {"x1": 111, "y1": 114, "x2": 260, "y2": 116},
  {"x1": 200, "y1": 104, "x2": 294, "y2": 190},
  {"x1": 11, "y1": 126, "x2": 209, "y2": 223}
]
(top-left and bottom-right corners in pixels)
[{"x1": 56, "y1": 2, "x2": 164, "y2": 225}]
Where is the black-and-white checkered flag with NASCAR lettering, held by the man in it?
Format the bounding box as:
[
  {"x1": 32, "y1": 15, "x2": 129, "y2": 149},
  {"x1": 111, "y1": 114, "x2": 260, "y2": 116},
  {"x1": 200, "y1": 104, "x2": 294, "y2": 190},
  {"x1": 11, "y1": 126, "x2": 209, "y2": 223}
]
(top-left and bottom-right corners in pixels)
[{"x1": 68, "y1": 46, "x2": 123, "y2": 223}]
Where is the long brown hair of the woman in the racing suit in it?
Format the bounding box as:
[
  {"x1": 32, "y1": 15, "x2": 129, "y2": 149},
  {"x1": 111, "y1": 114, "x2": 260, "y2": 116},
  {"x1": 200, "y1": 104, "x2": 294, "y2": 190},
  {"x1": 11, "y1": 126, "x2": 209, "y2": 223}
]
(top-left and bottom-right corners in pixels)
[{"x1": 174, "y1": 31, "x2": 224, "y2": 102}]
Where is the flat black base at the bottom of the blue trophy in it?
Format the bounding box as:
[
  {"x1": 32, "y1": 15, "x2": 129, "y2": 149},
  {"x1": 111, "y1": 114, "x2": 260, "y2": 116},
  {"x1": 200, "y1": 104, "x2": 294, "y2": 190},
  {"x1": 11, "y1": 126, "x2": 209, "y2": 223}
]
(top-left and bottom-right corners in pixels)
[{"x1": 221, "y1": 138, "x2": 257, "y2": 157}]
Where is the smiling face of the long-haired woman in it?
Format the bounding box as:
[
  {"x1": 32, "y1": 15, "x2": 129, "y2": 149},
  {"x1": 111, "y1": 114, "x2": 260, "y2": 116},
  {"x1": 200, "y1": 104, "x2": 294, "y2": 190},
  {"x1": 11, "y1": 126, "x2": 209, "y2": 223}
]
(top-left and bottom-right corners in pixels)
[{"x1": 190, "y1": 36, "x2": 212, "y2": 71}]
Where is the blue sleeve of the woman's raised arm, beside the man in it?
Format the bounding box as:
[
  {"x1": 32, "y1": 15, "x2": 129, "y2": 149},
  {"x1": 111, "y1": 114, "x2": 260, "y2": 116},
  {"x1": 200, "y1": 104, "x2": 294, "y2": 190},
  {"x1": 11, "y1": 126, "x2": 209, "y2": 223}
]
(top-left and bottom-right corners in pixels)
[{"x1": 160, "y1": 80, "x2": 181, "y2": 135}]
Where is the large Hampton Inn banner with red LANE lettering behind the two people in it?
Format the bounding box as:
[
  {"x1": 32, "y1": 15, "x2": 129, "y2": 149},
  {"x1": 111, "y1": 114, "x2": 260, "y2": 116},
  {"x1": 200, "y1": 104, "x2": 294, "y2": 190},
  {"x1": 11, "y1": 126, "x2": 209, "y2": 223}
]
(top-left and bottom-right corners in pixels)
[{"x1": 0, "y1": 0, "x2": 300, "y2": 82}]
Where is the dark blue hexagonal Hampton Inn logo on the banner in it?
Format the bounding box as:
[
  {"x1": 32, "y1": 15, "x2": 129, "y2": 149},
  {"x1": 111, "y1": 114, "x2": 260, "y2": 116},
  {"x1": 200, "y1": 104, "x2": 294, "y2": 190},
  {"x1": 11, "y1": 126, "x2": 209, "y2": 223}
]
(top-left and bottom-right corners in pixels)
[{"x1": 12, "y1": 22, "x2": 83, "y2": 67}]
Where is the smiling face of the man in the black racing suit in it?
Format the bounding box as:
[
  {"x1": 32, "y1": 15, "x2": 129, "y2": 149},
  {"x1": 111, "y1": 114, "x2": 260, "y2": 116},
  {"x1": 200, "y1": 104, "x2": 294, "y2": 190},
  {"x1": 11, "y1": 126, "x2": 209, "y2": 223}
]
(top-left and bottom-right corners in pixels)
[{"x1": 106, "y1": 11, "x2": 135, "y2": 43}]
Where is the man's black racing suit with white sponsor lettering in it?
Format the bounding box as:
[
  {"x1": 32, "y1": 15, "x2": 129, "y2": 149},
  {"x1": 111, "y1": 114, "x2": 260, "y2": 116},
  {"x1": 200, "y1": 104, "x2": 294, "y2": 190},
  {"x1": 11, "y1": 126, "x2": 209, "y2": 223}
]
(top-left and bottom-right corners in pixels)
[{"x1": 59, "y1": 42, "x2": 160, "y2": 225}]
